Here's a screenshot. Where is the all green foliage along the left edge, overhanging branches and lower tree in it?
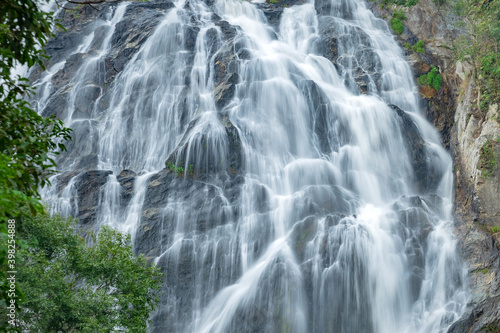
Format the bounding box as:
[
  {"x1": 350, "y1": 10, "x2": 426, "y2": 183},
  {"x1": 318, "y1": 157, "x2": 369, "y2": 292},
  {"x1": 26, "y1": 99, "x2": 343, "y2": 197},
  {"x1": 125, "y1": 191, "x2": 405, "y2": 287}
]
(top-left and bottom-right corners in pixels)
[{"x1": 0, "y1": 0, "x2": 159, "y2": 332}]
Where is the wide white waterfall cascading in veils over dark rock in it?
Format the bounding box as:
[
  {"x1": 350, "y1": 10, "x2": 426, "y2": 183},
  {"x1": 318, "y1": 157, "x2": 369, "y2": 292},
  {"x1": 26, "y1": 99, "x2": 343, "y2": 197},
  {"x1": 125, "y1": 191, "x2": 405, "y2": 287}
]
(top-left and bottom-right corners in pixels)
[{"x1": 37, "y1": 0, "x2": 467, "y2": 333}]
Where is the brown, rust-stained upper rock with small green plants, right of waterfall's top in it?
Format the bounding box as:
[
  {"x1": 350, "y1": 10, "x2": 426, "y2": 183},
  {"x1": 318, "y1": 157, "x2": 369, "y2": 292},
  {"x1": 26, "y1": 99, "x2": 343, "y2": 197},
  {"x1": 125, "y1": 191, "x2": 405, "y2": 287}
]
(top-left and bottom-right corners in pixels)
[{"x1": 368, "y1": 0, "x2": 464, "y2": 147}]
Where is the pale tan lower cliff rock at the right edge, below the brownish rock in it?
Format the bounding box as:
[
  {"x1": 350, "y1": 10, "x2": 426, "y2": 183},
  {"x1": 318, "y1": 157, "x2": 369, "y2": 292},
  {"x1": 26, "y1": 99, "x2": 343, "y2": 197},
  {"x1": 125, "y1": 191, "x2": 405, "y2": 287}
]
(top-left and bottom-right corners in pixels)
[{"x1": 449, "y1": 91, "x2": 500, "y2": 333}]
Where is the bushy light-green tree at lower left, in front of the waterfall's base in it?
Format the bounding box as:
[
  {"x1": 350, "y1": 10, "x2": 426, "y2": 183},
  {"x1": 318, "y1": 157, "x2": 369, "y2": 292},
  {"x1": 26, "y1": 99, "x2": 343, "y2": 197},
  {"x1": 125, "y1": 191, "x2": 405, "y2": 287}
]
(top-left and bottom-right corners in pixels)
[{"x1": 10, "y1": 211, "x2": 162, "y2": 333}]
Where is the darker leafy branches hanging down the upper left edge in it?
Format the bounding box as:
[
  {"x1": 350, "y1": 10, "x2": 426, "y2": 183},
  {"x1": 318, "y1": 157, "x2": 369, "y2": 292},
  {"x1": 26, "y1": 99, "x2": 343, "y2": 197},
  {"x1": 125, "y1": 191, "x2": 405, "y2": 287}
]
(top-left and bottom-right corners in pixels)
[{"x1": 0, "y1": 0, "x2": 70, "y2": 330}]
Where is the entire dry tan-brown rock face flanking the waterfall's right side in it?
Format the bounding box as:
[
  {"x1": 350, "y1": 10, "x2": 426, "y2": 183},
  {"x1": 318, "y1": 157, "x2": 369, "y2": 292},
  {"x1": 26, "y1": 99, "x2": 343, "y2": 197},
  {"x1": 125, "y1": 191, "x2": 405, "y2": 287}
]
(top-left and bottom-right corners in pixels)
[{"x1": 370, "y1": 0, "x2": 500, "y2": 333}]
